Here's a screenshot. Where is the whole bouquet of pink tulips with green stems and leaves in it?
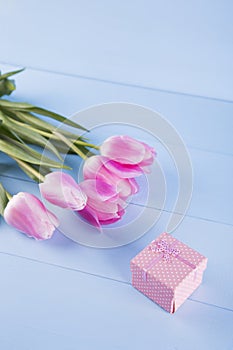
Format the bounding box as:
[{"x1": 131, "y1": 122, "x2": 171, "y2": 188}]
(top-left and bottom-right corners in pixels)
[{"x1": 0, "y1": 71, "x2": 155, "y2": 239}]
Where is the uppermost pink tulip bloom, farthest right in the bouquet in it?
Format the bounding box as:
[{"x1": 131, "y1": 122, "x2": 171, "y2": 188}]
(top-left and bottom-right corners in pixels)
[{"x1": 100, "y1": 135, "x2": 155, "y2": 173}]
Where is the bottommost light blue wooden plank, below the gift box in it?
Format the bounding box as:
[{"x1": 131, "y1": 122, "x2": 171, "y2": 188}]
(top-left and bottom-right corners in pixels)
[{"x1": 0, "y1": 254, "x2": 233, "y2": 350}]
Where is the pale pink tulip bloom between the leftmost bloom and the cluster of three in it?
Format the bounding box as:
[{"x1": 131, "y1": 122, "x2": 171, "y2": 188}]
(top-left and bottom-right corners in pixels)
[{"x1": 39, "y1": 171, "x2": 87, "y2": 210}]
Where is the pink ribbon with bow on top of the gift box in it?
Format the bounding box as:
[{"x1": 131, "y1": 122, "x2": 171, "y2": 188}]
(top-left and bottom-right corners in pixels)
[{"x1": 143, "y1": 239, "x2": 196, "y2": 281}]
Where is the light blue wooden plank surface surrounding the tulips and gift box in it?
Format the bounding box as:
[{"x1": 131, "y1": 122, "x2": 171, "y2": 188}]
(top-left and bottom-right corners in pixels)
[{"x1": 0, "y1": 0, "x2": 233, "y2": 350}]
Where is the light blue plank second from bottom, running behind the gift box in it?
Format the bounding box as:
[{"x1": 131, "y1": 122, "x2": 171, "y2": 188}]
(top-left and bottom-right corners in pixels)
[{"x1": 0, "y1": 176, "x2": 233, "y2": 308}]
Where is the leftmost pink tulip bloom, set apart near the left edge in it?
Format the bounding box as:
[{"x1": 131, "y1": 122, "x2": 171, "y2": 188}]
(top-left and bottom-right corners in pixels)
[{"x1": 4, "y1": 192, "x2": 59, "y2": 239}]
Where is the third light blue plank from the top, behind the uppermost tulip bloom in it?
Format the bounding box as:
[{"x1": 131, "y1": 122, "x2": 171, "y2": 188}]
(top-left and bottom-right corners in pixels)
[{"x1": 0, "y1": 140, "x2": 233, "y2": 224}]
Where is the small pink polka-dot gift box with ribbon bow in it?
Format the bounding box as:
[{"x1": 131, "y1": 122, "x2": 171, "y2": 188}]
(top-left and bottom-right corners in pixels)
[{"x1": 130, "y1": 233, "x2": 207, "y2": 313}]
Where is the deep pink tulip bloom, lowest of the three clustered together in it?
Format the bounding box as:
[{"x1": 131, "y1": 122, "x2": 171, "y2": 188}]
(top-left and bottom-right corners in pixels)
[{"x1": 79, "y1": 179, "x2": 125, "y2": 229}]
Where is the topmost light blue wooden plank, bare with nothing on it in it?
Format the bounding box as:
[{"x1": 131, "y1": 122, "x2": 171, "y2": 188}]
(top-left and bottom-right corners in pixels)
[{"x1": 0, "y1": 0, "x2": 233, "y2": 100}]
